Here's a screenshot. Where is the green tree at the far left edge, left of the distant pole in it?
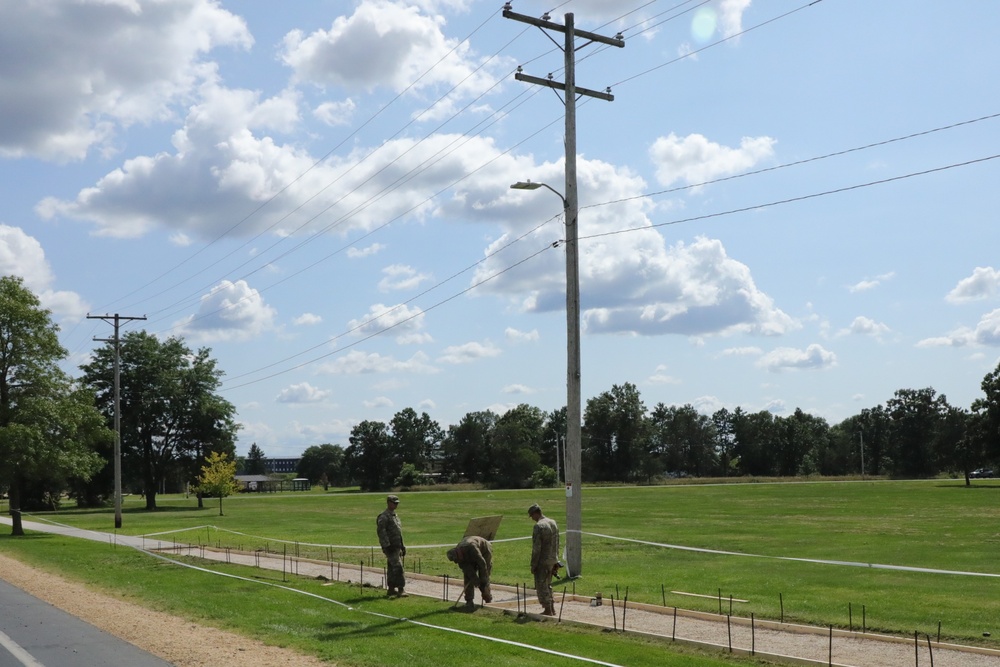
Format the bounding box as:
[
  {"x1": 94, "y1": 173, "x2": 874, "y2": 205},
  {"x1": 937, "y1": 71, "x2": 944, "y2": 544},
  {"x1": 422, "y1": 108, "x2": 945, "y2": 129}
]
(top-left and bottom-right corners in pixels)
[{"x1": 0, "y1": 276, "x2": 114, "y2": 535}]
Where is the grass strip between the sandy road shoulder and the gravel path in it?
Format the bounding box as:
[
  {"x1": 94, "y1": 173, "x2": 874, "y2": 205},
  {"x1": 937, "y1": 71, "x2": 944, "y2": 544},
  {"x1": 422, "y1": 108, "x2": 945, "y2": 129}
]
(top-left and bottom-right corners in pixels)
[{"x1": 0, "y1": 534, "x2": 764, "y2": 667}]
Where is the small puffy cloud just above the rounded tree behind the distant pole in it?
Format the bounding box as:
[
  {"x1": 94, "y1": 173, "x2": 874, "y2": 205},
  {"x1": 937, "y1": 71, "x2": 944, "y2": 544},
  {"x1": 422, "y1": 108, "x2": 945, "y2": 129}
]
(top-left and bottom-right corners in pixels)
[{"x1": 175, "y1": 280, "x2": 276, "y2": 342}]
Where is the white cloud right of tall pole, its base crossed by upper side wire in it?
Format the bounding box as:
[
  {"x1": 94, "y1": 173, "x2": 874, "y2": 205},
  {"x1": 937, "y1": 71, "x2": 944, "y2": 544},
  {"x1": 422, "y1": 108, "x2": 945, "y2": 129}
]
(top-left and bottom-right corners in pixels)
[{"x1": 649, "y1": 133, "x2": 776, "y2": 186}]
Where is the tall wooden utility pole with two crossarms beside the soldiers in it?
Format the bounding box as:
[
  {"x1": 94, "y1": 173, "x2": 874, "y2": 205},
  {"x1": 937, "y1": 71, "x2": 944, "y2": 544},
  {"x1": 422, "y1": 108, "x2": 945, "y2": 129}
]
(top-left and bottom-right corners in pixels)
[{"x1": 503, "y1": 2, "x2": 625, "y2": 577}]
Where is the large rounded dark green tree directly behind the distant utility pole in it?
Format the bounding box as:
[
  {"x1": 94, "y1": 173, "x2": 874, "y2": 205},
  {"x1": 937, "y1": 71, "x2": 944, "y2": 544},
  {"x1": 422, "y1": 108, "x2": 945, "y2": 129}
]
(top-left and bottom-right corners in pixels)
[{"x1": 82, "y1": 331, "x2": 238, "y2": 510}]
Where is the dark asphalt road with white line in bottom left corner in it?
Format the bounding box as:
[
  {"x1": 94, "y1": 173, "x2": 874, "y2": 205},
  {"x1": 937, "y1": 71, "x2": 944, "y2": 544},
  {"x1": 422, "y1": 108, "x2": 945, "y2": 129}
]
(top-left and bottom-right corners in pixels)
[{"x1": 0, "y1": 579, "x2": 170, "y2": 667}]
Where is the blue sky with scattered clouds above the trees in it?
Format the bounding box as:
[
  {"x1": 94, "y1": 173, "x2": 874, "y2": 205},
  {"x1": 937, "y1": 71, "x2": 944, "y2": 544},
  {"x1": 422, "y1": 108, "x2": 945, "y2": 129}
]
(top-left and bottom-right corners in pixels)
[{"x1": 0, "y1": 0, "x2": 1000, "y2": 457}]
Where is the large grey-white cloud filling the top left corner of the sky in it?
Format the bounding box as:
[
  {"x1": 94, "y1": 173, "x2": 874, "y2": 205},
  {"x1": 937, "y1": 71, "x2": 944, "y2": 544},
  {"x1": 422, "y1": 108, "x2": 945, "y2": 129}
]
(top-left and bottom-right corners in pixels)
[{"x1": 0, "y1": 0, "x2": 253, "y2": 161}]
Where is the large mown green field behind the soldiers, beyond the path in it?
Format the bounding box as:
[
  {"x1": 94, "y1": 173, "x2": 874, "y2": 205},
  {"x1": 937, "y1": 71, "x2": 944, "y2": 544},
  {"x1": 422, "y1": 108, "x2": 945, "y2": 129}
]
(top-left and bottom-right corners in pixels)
[{"x1": 0, "y1": 480, "x2": 1000, "y2": 665}]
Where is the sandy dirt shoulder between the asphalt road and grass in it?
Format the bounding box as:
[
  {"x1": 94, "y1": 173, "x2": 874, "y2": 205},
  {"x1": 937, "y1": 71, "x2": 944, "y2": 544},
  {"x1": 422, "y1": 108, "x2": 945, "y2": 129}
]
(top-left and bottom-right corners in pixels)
[{"x1": 0, "y1": 556, "x2": 330, "y2": 667}]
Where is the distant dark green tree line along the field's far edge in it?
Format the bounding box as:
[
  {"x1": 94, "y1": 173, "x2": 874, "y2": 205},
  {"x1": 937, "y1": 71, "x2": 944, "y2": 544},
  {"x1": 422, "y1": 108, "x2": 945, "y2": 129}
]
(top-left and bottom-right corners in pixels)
[{"x1": 299, "y1": 380, "x2": 1000, "y2": 490}]
